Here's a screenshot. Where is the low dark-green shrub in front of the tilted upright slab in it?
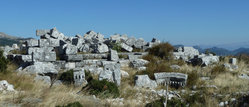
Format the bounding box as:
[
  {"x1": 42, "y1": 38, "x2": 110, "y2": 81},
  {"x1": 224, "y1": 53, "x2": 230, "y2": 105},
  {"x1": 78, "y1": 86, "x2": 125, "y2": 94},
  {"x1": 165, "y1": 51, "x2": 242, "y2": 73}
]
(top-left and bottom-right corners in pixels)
[{"x1": 83, "y1": 79, "x2": 120, "y2": 98}]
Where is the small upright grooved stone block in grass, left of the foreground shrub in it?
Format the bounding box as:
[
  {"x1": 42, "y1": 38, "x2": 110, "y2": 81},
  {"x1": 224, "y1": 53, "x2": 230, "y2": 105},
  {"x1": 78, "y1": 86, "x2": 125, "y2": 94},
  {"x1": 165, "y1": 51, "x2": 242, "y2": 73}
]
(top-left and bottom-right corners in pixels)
[{"x1": 73, "y1": 69, "x2": 87, "y2": 86}]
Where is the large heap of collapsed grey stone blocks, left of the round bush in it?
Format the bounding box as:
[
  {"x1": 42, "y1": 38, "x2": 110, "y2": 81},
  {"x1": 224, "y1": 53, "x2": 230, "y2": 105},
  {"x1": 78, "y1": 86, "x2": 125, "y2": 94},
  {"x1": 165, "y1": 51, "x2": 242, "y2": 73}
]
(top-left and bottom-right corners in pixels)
[{"x1": 7, "y1": 28, "x2": 160, "y2": 85}]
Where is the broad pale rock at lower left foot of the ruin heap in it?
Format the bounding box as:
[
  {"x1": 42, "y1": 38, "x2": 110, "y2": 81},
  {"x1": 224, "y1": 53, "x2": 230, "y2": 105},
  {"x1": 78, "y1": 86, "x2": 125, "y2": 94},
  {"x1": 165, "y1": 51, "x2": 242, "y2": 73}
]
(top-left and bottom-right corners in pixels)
[{"x1": 23, "y1": 62, "x2": 58, "y2": 74}]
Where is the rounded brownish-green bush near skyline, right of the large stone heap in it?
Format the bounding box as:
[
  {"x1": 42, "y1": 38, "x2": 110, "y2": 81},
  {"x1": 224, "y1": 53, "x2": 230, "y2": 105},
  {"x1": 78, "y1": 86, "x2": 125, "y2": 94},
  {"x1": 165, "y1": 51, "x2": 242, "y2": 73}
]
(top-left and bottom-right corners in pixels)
[{"x1": 149, "y1": 42, "x2": 174, "y2": 60}]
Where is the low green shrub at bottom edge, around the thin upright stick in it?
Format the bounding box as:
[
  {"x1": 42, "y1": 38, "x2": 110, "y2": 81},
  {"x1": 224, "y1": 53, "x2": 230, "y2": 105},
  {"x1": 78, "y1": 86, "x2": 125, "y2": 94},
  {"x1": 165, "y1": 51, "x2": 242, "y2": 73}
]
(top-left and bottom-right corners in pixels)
[{"x1": 145, "y1": 97, "x2": 186, "y2": 107}]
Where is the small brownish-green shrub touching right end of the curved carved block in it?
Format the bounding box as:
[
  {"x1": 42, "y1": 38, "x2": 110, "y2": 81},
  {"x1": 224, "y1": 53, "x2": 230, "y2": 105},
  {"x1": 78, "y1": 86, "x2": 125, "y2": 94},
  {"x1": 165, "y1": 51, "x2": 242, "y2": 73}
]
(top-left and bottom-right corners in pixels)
[{"x1": 187, "y1": 71, "x2": 199, "y2": 87}]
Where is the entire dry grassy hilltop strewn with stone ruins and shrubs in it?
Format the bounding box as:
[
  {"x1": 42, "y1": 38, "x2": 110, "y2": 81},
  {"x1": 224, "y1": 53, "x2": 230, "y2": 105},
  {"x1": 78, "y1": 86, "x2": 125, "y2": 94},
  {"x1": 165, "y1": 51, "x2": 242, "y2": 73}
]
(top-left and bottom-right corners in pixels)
[{"x1": 0, "y1": 28, "x2": 249, "y2": 107}]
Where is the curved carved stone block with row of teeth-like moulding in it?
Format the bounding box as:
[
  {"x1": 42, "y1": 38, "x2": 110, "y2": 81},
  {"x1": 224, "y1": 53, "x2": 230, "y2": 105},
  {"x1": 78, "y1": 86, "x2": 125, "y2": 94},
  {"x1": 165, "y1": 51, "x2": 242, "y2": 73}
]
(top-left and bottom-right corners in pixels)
[{"x1": 154, "y1": 72, "x2": 188, "y2": 87}]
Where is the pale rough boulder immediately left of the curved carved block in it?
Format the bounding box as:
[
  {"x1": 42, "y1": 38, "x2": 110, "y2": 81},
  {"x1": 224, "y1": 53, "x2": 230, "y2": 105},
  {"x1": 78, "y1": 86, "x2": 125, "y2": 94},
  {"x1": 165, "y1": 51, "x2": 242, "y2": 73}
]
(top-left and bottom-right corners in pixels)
[{"x1": 135, "y1": 75, "x2": 157, "y2": 89}]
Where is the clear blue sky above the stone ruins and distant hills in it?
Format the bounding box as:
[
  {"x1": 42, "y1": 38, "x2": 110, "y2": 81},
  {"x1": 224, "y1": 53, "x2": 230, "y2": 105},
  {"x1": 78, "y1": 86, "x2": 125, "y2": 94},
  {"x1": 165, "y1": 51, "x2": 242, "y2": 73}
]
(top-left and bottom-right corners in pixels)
[{"x1": 0, "y1": 0, "x2": 249, "y2": 45}]
